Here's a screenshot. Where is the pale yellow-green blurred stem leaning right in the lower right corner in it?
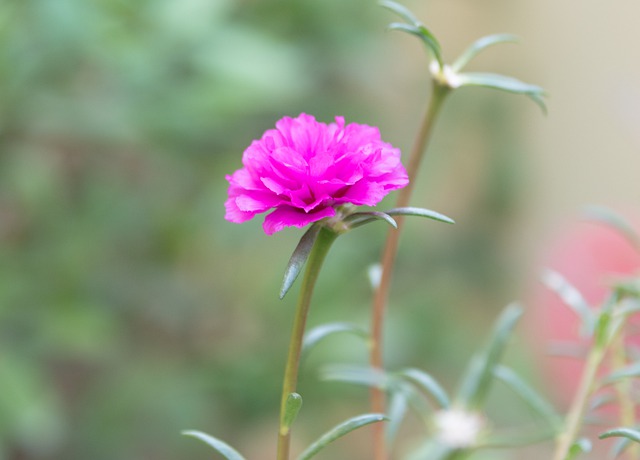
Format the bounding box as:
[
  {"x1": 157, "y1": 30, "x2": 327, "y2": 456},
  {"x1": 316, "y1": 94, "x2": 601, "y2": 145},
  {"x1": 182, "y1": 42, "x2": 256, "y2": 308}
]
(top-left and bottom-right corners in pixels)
[{"x1": 553, "y1": 345, "x2": 607, "y2": 460}]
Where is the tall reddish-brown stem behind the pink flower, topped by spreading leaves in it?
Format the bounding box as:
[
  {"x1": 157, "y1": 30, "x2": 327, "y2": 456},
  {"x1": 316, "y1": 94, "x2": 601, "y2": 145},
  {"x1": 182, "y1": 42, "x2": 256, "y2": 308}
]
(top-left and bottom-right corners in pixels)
[{"x1": 370, "y1": 81, "x2": 449, "y2": 460}]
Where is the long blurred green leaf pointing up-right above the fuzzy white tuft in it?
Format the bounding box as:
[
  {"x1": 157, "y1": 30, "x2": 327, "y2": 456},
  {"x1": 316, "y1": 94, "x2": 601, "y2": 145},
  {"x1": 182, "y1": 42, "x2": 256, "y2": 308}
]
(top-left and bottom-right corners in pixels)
[{"x1": 458, "y1": 304, "x2": 522, "y2": 409}]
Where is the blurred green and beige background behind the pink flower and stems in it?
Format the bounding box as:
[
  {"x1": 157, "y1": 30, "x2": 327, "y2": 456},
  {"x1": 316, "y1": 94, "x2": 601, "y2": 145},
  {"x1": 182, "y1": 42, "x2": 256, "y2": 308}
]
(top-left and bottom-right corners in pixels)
[{"x1": 0, "y1": 0, "x2": 640, "y2": 460}]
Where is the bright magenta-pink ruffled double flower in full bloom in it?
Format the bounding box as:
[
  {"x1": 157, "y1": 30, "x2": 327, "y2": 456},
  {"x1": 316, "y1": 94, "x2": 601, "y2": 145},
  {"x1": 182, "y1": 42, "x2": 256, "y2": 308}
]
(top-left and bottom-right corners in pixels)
[{"x1": 225, "y1": 113, "x2": 409, "y2": 235}]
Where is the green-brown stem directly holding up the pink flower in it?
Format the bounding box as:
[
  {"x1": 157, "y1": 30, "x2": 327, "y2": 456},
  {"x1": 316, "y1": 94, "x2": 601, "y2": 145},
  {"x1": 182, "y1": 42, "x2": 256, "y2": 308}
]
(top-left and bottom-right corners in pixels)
[{"x1": 277, "y1": 227, "x2": 338, "y2": 460}]
